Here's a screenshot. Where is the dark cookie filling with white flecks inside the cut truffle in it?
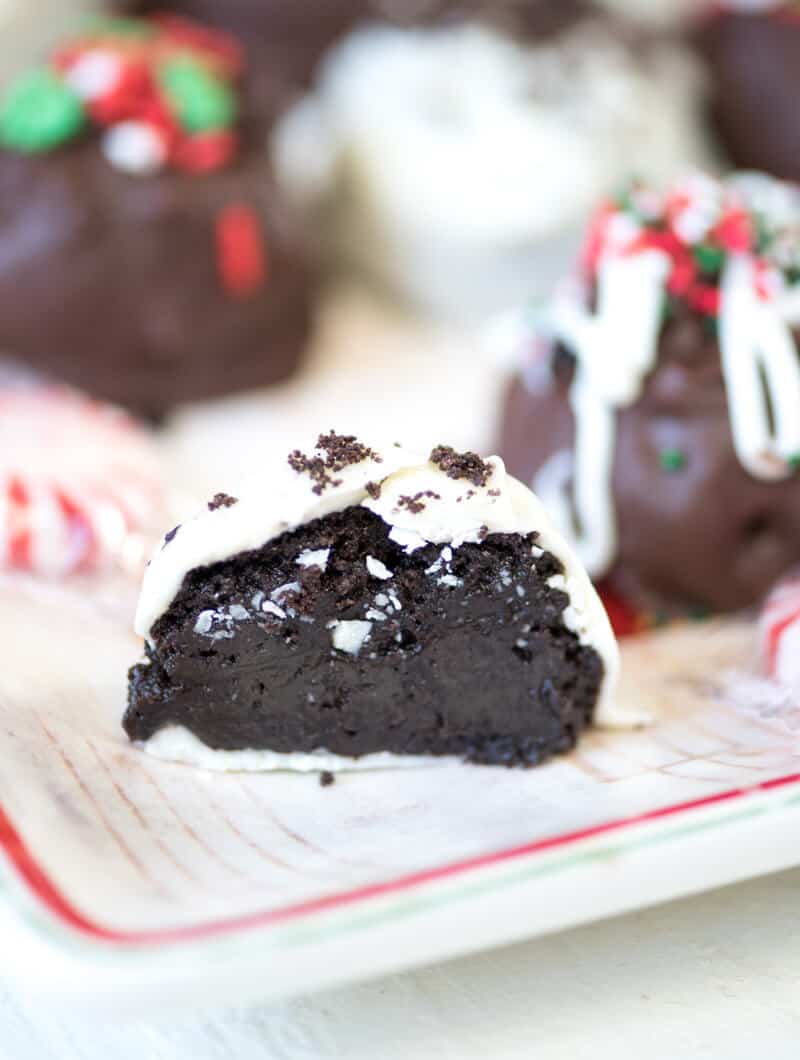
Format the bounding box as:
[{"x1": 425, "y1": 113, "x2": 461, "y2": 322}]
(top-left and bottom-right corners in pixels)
[{"x1": 124, "y1": 508, "x2": 603, "y2": 765}]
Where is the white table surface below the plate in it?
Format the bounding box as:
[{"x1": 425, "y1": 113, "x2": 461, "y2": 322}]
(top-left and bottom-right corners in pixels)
[{"x1": 0, "y1": 869, "x2": 800, "y2": 1060}]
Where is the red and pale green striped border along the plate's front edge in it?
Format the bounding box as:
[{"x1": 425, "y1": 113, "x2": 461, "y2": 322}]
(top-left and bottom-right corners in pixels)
[{"x1": 0, "y1": 772, "x2": 800, "y2": 959}]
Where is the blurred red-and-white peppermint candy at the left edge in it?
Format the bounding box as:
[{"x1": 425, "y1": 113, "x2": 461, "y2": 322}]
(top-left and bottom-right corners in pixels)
[{"x1": 0, "y1": 383, "x2": 164, "y2": 578}]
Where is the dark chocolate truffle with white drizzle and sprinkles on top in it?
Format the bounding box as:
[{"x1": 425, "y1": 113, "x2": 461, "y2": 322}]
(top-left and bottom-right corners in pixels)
[{"x1": 501, "y1": 174, "x2": 800, "y2": 629}]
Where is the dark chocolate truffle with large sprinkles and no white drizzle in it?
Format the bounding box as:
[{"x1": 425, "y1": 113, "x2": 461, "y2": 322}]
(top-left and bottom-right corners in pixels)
[{"x1": 0, "y1": 15, "x2": 313, "y2": 418}]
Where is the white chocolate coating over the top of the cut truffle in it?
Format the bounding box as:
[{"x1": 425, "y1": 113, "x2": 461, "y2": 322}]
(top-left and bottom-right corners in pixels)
[{"x1": 136, "y1": 434, "x2": 619, "y2": 725}]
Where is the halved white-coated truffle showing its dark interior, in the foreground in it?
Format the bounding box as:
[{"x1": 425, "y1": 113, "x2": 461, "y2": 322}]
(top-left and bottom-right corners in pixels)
[{"x1": 124, "y1": 431, "x2": 618, "y2": 770}]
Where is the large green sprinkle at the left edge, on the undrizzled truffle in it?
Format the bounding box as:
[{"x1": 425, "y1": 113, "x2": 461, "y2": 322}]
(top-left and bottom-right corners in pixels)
[{"x1": 0, "y1": 69, "x2": 86, "y2": 154}]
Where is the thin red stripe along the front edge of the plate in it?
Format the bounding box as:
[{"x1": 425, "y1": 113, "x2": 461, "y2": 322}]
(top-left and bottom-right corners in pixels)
[{"x1": 0, "y1": 773, "x2": 800, "y2": 946}]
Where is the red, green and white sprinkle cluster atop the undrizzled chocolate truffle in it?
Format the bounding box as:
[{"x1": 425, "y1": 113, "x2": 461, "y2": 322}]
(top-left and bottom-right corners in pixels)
[{"x1": 0, "y1": 15, "x2": 243, "y2": 175}]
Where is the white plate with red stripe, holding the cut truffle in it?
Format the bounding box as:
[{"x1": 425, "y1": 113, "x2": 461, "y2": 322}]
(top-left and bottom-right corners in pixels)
[{"x1": 0, "y1": 580, "x2": 800, "y2": 1011}]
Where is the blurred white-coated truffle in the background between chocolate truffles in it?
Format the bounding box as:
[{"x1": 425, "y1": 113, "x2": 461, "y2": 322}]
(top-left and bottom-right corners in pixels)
[{"x1": 275, "y1": 0, "x2": 708, "y2": 317}]
